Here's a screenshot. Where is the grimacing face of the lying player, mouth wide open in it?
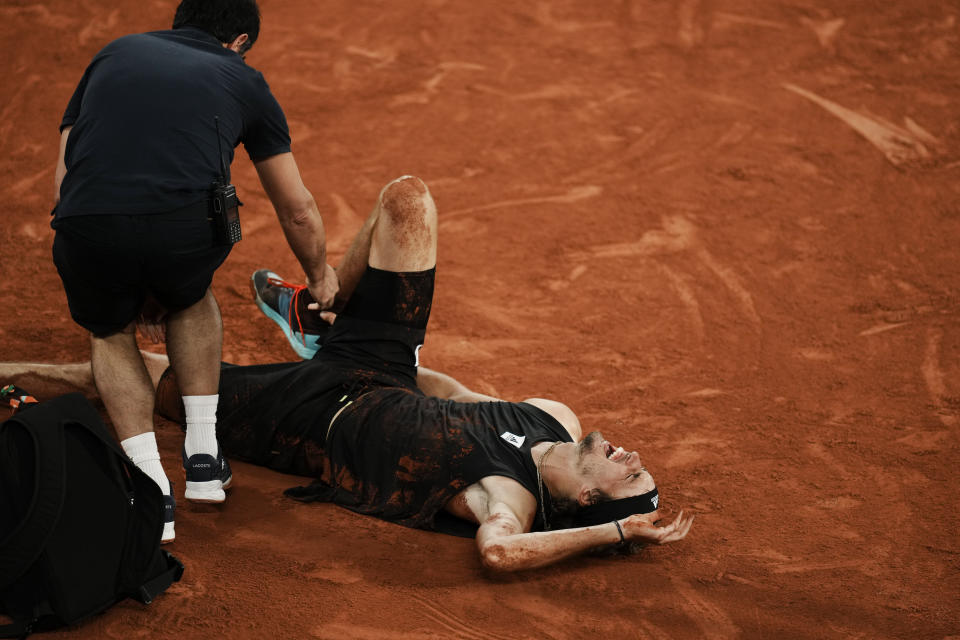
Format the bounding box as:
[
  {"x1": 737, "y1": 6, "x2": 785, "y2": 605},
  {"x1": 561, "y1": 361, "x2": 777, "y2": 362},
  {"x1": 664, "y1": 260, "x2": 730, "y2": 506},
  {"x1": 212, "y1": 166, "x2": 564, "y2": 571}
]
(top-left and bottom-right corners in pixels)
[{"x1": 578, "y1": 431, "x2": 658, "y2": 521}]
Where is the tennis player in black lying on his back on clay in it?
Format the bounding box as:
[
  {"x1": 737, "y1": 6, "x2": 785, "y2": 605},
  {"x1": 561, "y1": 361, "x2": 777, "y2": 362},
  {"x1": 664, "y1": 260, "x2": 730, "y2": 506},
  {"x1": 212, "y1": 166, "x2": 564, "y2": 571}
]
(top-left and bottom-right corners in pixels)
[{"x1": 0, "y1": 176, "x2": 693, "y2": 571}]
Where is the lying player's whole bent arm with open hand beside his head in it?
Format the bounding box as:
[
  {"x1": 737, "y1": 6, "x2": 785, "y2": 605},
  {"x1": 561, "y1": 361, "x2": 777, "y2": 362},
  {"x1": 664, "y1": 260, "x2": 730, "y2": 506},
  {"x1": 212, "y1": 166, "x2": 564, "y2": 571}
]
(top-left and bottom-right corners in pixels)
[{"x1": 477, "y1": 479, "x2": 693, "y2": 571}]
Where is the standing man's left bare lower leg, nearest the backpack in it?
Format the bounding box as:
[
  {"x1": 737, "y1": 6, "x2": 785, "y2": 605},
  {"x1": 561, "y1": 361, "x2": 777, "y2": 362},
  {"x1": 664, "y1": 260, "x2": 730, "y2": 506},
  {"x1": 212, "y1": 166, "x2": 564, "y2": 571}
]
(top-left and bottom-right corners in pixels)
[{"x1": 90, "y1": 322, "x2": 154, "y2": 440}]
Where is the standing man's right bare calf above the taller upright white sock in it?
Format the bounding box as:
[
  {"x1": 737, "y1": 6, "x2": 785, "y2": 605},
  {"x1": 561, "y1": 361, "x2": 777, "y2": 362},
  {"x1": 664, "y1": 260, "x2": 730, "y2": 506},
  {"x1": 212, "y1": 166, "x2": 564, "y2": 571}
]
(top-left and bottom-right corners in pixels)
[{"x1": 169, "y1": 289, "x2": 223, "y2": 398}]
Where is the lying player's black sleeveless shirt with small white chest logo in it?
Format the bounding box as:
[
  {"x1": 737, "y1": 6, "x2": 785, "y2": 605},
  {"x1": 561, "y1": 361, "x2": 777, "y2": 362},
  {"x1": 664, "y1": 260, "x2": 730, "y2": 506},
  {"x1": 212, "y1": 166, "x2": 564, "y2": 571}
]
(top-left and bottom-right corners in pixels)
[{"x1": 288, "y1": 388, "x2": 572, "y2": 536}]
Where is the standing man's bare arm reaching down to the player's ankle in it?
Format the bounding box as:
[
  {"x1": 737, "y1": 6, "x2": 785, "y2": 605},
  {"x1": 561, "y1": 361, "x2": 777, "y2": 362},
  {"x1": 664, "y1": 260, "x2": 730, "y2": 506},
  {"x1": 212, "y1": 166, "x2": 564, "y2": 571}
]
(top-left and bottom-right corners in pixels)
[{"x1": 254, "y1": 152, "x2": 340, "y2": 309}]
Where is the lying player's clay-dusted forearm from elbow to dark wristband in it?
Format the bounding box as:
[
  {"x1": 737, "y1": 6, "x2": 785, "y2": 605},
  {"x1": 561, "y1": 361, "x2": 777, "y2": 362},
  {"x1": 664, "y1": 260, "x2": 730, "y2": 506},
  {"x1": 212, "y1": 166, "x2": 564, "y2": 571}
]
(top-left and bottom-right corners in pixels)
[{"x1": 477, "y1": 522, "x2": 620, "y2": 571}]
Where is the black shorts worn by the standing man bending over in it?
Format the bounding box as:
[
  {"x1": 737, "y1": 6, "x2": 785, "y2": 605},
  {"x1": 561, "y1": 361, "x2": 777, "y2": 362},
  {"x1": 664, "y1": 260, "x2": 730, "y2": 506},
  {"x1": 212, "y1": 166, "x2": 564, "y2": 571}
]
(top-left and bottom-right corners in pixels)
[{"x1": 53, "y1": 206, "x2": 230, "y2": 337}]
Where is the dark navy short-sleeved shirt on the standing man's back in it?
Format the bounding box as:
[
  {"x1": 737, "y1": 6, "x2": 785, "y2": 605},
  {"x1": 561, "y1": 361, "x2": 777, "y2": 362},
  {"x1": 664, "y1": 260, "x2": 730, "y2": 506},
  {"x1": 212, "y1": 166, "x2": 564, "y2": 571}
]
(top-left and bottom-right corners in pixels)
[{"x1": 56, "y1": 27, "x2": 290, "y2": 218}]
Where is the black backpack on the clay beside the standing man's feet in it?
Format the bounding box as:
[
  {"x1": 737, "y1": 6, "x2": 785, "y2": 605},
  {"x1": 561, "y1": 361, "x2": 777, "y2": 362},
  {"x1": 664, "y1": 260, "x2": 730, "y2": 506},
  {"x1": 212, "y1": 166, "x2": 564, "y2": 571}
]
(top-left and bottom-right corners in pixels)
[{"x1": 0, "y1": 393, "x2": 183, "y2": 637}]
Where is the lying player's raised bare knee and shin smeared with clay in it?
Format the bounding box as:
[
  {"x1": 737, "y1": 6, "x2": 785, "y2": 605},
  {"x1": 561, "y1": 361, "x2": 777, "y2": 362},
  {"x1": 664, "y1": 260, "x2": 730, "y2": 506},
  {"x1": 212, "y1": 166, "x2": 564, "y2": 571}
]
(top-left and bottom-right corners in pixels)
[{"x1": 337, "y1": 176, "x2": 437, "y2": 300}]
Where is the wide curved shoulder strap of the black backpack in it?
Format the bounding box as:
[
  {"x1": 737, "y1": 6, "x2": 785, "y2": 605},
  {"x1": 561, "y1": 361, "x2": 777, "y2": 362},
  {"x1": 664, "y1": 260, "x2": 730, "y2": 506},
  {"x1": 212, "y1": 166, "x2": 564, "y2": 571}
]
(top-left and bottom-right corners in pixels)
[{"x1": 0, "y1": 393, "x2": 74, "y2": 589}]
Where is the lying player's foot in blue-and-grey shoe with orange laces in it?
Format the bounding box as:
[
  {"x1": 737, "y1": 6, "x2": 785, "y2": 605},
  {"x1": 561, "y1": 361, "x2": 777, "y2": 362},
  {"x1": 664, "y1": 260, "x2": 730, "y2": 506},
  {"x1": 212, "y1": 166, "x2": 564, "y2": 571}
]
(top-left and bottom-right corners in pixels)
[{"x1": 250, "y1": 269, "x2": 330, "y2": 360}]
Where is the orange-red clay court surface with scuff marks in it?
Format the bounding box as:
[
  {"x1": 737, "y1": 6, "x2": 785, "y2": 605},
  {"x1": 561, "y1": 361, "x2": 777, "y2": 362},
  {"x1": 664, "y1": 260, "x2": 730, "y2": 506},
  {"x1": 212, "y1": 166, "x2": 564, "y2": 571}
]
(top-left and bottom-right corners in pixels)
[{"x1": 0, "y1": 0, "x2": 960, "y2": 640}]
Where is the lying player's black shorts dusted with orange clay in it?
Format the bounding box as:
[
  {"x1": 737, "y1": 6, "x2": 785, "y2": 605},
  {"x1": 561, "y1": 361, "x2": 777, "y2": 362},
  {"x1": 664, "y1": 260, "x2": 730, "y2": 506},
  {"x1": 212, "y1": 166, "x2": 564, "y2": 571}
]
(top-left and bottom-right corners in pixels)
[{"x1": 156, "y1": 267, "x2": 435, "y2": 476}]
